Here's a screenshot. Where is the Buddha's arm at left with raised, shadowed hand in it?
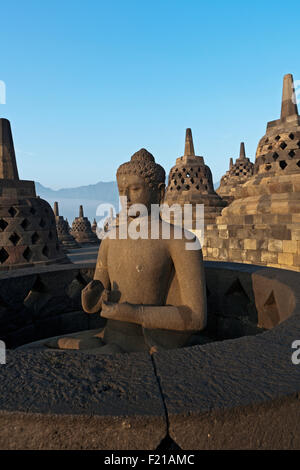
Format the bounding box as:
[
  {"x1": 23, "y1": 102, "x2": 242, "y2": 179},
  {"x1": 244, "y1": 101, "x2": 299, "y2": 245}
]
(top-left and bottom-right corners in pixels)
[{"x1": 81, "y1": 239, "x2": 110, "y2": 313}]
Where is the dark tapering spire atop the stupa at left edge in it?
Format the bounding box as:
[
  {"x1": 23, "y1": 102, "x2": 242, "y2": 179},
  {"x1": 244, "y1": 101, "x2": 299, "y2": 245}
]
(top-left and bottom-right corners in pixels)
[{"x1": 0, "y1": 118, "x2": 19, "y2": 180}]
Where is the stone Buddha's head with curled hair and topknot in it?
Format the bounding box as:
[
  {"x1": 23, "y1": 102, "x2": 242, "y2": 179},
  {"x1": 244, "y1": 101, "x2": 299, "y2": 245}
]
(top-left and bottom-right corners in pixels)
[{"x1": 117, "y1": 149, "x2": 166, "y2": 212}]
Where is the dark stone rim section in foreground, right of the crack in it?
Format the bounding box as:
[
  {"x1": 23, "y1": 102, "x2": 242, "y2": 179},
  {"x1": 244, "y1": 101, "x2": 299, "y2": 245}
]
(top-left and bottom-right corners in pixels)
[{"x1": 154, "y1": 328, "x2": 300, "y2": 450}]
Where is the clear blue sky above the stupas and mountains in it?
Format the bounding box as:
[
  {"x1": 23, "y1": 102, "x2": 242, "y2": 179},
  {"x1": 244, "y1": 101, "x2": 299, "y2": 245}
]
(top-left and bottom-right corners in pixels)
[{"x1": 0, "y1": 0, "x2": 300, "y2": 189}]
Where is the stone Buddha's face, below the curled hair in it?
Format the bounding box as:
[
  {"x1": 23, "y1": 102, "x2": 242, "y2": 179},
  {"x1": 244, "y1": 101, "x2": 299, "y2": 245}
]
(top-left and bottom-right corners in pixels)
[{"x1": 117, "y1": 174, "x2": 164, "y2": 213}]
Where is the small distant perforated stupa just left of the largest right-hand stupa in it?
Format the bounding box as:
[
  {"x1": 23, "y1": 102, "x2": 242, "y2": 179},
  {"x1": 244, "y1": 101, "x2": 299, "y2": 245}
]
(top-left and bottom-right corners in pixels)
[{"x1": 216, "y1": 142, "x2": 254, "y2": 202}]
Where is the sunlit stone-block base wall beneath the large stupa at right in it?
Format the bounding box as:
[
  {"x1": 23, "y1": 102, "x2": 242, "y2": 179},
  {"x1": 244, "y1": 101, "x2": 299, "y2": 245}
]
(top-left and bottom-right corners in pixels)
[{"x1": 203, "y1": 214, "x2": 300, "y2": 271}]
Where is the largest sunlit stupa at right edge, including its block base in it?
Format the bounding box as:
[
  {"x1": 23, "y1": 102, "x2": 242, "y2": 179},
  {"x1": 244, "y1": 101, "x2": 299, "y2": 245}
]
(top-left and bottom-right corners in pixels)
[{"x1": 206, "y1": 74, "x2": 300, "y2": 271}]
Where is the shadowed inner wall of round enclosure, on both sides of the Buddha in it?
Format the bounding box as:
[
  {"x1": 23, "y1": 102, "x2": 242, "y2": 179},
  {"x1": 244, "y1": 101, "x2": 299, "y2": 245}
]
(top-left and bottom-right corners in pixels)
[{"x1": 0, "y1": 262, "x2": 293, "y2": 348}]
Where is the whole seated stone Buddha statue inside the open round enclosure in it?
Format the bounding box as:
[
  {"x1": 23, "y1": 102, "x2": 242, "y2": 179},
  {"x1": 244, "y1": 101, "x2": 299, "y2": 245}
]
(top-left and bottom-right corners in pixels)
[{"x1": 47, "y1": 149, "x2": 207, "y2": 354}]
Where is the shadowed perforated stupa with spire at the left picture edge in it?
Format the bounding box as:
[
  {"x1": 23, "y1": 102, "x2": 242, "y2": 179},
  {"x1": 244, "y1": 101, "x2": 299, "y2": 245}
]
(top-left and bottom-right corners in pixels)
[{"x1": 0, "y1": 119, "x2": 69, "y2": 270}]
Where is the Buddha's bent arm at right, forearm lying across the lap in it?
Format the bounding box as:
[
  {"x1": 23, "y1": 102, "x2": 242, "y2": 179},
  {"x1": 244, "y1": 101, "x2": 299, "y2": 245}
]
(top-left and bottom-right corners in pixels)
[{"x1": 101, "y1": 235, "x2": 206, "y2": 331}]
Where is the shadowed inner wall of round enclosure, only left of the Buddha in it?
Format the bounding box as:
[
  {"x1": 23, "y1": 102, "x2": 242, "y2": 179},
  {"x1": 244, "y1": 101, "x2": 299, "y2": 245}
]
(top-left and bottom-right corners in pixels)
[{"x1": 0, "y1": 263, "x2": 104, "y2": 348}]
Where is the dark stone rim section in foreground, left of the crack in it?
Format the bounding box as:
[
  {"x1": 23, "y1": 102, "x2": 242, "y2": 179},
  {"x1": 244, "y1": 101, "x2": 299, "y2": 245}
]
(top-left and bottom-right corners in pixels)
[{"x1": 0, "y1": 351, "x2": 167, "y2": 450}]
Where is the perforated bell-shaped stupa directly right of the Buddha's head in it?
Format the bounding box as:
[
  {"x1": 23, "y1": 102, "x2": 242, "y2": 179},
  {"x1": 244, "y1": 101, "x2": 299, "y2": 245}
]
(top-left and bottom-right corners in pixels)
[{"x1": 165, "y1": 129, "x2": 227, "y2": 224}]
